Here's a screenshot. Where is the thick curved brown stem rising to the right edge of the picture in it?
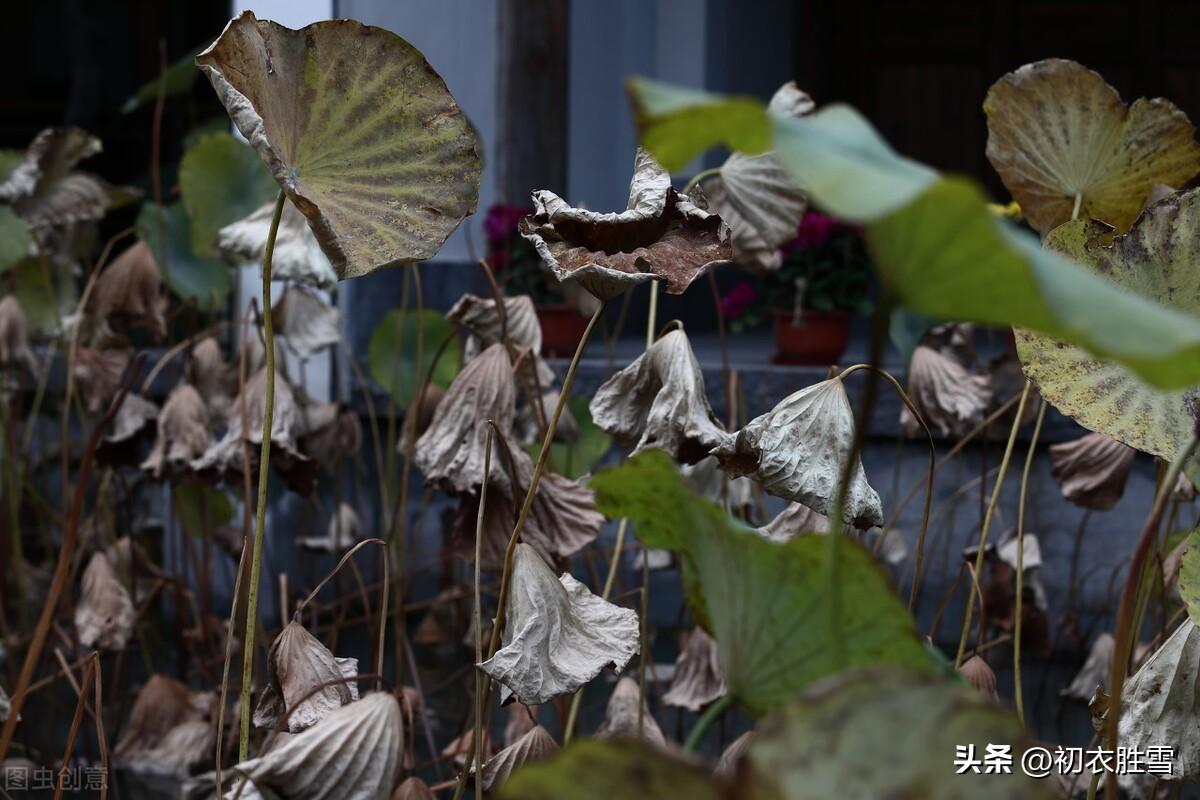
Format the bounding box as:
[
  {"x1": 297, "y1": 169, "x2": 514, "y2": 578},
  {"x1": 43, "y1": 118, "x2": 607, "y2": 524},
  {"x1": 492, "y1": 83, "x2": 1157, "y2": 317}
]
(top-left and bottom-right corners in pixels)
[{"x1": 1104, "y1": 428, "x2": 1200, "y2": 799}]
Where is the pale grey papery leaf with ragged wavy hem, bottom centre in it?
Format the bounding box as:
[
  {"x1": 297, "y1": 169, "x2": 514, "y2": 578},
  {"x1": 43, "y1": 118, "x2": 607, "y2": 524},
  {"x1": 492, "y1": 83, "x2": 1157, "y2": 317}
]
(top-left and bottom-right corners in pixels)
[{"x1": 479, "y1": 543, "x2": 638, "y2": 705}]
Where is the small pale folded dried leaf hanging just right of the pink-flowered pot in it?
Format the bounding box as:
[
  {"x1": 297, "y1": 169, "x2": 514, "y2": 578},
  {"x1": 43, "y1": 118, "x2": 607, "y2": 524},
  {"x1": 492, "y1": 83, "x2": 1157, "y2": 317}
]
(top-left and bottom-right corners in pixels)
[{"x1": 900, "y1": 345, "x2": 991, "y2": 437}]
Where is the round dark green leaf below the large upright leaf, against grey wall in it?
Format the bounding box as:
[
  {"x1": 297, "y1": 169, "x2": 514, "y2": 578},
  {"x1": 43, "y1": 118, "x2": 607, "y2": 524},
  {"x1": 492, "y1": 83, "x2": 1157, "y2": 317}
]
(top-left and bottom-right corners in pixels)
[{"x1": 367, "y1": 308, "x2": 462, "y2": 408}]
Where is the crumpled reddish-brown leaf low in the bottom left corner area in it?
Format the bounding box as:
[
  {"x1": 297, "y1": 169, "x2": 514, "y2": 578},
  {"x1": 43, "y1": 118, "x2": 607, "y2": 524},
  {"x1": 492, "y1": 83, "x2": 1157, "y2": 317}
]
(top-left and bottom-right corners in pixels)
[{"x1": 113, "y1": 674, "x2": 216, "y2": 777}]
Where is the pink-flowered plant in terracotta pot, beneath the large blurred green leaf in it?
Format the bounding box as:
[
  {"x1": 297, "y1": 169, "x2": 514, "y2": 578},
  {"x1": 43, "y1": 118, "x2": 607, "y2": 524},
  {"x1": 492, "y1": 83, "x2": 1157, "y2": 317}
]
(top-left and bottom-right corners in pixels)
[{"x1": 764, "y1": 210, "x2": 872, "y2": 365}]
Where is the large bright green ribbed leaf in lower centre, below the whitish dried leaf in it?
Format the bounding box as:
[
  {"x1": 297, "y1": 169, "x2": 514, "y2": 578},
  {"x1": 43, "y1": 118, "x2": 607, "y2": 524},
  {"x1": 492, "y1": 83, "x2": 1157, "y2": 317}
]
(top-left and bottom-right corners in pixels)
[{"x1": 590, "y1": 450, "x2": 935, "y2": 716}]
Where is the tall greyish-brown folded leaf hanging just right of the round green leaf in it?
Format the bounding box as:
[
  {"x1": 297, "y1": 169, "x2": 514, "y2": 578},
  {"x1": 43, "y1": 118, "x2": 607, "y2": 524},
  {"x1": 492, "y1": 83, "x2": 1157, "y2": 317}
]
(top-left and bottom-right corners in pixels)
[{"x1": 413, "y1": 344, "x2": 516, "y2": 493}]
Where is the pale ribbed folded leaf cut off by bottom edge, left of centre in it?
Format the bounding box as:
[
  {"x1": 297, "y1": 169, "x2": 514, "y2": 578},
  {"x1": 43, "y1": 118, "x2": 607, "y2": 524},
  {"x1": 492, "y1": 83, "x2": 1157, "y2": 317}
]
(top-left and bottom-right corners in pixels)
[{"x1": 234, "y1": 692, "x2": 404, "y2": 800}]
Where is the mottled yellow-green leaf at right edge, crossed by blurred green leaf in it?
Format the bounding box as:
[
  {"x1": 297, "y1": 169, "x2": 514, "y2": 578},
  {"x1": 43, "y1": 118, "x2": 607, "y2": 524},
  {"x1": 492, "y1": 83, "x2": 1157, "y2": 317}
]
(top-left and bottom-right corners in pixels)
[{"x1": 1016, "y1": 191, "x2": 1200, "y2": 461}]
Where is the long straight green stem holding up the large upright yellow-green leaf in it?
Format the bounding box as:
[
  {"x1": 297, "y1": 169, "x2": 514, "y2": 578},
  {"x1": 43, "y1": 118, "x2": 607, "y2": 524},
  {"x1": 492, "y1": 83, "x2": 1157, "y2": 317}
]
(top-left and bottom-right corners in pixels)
[{"x1": 238, "y1": 190, "x2": 287, "y2": 762}]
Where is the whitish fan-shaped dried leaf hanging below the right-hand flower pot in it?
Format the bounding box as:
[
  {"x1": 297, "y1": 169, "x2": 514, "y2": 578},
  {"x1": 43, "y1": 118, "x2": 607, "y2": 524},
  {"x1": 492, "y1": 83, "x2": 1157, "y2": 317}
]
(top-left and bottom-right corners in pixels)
[{"x1": 713, "y1": 378, "x2": 883, "y2": 528}]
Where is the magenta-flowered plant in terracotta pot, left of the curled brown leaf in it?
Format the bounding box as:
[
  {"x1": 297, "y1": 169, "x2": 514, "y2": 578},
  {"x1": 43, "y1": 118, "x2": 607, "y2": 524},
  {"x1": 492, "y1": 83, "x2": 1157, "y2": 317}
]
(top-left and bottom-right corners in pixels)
[{"x1": 484, "y1": 203, "x2": 588, "y2": 357}]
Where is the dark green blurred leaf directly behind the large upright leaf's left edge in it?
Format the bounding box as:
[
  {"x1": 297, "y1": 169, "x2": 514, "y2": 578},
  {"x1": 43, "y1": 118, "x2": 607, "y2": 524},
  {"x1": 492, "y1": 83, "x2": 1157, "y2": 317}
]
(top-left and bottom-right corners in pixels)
[{"x1": 179, "y1": 131, "x2": 278, "y2": 258}]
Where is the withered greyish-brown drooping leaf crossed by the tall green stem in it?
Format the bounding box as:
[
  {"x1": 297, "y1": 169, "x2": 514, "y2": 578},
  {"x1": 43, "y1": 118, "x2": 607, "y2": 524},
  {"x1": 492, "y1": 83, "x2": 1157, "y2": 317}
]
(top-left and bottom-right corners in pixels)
[{"x1": 192, "y1": 367, "x2": 317, "y2": 497}]
